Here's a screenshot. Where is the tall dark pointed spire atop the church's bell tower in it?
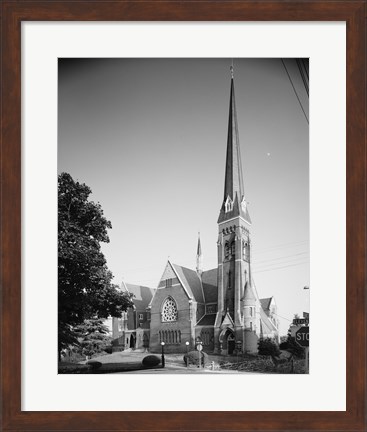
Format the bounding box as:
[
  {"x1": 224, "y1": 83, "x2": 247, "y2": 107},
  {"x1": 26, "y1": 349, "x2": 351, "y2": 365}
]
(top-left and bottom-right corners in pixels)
[{"x1": 218, "y1": 64, "x2": 251, "y2": 224}]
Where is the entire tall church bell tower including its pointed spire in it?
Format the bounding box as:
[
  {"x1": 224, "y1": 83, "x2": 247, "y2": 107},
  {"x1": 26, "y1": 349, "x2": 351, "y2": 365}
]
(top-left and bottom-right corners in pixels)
[{"x1": 214, "y1": 66, "x2": 252, "y2": 352}]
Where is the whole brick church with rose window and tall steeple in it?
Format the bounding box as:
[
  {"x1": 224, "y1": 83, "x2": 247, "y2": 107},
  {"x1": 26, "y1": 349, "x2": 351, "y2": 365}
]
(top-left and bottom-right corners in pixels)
[{"x1": 112, "y1": 68, "x2": 279, "y2": 354}]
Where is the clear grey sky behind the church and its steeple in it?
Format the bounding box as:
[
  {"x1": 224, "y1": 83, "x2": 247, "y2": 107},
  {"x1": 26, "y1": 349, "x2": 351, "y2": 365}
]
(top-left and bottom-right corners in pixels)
[{"x1": 58, "y1": 58, "x2": 310, "y2": 334}]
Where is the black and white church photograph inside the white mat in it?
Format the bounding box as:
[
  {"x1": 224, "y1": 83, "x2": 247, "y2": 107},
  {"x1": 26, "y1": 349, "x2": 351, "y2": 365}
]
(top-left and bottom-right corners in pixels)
[{"x1": 55, "y1": 58, "x2": 312, "y2": 374}]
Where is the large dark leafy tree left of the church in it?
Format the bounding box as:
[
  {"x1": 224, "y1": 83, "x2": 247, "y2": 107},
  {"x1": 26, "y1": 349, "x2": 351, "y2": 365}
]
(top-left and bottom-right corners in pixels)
[{"x1": 58, "y1": 173, "x2": 133, "y2": 352}]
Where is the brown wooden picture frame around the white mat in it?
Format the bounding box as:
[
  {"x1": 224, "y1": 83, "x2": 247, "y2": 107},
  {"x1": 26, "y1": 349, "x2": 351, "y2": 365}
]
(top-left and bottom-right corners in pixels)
[{"x1": 1, "y1": 0, "x2": 367, "y2": 431}]
